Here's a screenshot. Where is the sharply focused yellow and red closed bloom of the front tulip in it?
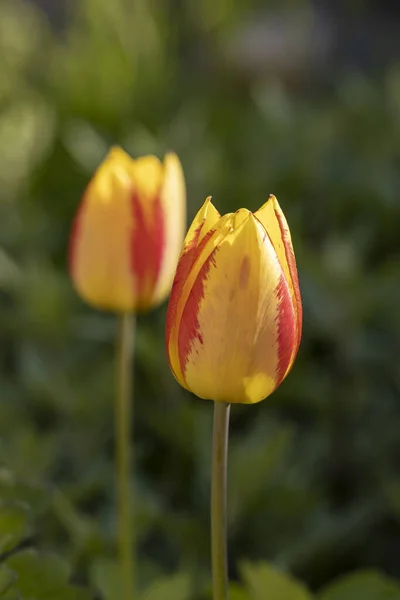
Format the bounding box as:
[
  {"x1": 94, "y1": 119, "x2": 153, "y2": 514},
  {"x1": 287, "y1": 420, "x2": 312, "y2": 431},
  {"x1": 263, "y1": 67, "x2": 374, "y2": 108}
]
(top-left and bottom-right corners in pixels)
[{"x1": 166, "y1": 196, "x2": 302, "y2": 404}]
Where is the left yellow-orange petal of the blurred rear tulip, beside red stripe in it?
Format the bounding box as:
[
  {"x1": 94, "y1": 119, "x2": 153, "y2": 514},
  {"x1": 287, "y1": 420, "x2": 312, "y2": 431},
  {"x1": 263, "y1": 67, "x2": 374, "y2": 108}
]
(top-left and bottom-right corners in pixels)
[{"x1": 69, "y1": 148, "x2": 134, "y2": 311}]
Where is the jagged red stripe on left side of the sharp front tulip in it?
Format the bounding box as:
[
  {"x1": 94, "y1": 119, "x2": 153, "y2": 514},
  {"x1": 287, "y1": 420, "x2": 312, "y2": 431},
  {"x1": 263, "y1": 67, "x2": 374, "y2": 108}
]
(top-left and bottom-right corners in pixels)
[{"x1": 178, "y1": 238, "x2": 218, "y2": 377}]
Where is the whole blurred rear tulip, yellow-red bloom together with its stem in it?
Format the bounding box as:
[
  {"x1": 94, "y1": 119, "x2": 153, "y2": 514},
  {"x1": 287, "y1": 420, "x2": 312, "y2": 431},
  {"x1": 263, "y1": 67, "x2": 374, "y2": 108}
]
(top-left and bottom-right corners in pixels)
[{"x1": 69, "y1": 148, "x2": 186, "y2": 600}]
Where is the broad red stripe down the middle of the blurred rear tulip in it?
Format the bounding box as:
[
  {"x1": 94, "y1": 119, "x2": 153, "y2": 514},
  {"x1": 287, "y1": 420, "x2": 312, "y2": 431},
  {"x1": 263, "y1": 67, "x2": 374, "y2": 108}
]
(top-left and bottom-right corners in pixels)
[{"x1": 131, "y1": 193, "x2": 165, "y2": 306}]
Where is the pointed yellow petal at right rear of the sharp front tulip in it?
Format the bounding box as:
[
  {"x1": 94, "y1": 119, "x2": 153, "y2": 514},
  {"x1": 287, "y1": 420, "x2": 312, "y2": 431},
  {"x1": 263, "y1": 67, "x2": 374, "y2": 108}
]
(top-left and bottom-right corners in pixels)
[{"x1": 254, "y1": 194, "x2": 303, "y2": 371}]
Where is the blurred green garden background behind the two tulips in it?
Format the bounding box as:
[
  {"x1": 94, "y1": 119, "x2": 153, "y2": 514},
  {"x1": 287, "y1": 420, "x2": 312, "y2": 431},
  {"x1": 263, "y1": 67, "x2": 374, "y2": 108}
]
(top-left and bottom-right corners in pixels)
[{"x1": 0, "y1": 0, "x2": 400, "y2": 600}]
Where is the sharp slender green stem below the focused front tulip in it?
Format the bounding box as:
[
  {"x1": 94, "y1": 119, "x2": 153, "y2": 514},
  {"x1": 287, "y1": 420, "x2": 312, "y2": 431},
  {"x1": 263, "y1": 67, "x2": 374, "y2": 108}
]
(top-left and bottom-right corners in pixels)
[{"x1": 211, "y1": 402, "x2": 230, "y2": 600}]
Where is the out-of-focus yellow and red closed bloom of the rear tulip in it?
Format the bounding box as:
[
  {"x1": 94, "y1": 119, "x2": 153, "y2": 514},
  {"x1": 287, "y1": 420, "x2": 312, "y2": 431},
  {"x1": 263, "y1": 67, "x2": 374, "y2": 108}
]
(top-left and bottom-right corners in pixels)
[{"x1": 69, "y1": 148, "x2": 186, "y2": 312}]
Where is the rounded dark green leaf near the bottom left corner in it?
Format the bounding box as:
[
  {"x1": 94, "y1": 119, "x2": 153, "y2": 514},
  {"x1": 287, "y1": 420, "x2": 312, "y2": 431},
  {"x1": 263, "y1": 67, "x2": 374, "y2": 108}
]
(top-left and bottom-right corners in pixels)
[{"x1": 7, "y1": 550, "x2": 70, "y2": 600}]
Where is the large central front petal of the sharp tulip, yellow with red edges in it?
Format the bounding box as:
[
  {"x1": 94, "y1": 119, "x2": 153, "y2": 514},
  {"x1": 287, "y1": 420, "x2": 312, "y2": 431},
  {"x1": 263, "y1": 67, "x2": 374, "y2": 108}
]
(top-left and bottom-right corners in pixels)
[{"x1": 175, "y1": 209, "x2": 296, "y2": 403}]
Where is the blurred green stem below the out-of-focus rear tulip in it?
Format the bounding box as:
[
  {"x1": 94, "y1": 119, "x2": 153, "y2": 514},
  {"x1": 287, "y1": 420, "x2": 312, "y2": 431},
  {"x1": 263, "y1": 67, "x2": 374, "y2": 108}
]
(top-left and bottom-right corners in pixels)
[{"x1": 115, "y1": 313, "x2": 135, "y2": 600}]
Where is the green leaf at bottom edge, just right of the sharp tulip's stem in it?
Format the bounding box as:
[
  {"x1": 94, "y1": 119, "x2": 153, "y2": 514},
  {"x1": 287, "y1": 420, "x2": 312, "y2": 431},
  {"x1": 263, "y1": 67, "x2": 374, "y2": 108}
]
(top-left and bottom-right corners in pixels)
[{"x1": 241, "y1": 563, "x2": 314, "y2": 600}]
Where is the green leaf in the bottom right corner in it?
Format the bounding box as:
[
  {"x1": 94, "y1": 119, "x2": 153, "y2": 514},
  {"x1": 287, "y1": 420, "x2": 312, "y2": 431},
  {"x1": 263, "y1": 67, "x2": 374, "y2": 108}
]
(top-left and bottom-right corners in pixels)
[{"x1": 318, "y1": 571, "x2": 400, "y2": 600}]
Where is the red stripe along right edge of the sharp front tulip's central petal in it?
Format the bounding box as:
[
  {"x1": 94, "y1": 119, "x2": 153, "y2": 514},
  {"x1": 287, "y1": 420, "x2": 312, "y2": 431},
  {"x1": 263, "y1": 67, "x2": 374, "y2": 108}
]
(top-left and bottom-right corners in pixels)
[{"x1": 275, "y1": 273, "x2": 297, "y2": 389}]
